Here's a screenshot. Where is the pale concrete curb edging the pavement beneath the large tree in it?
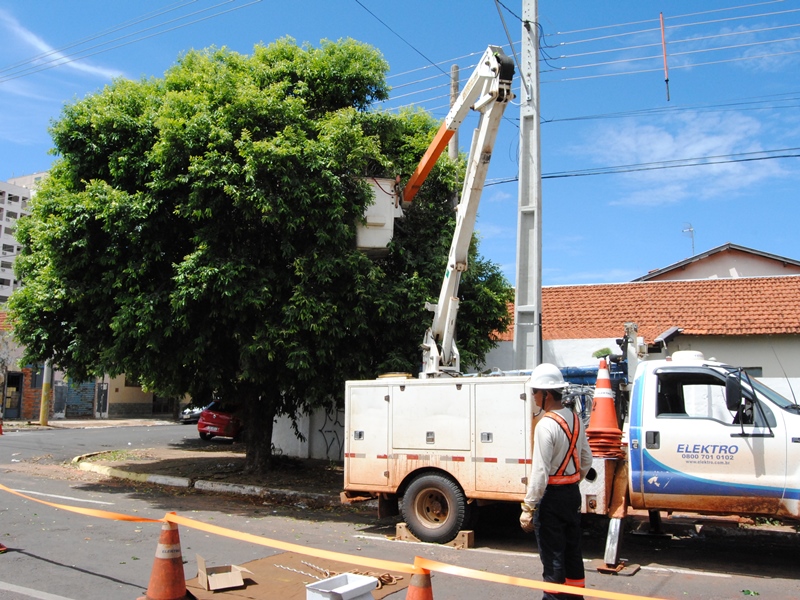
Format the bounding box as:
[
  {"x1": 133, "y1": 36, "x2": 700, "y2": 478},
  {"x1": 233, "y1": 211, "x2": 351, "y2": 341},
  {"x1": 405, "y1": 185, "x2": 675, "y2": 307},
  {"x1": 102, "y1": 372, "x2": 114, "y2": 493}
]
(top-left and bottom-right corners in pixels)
[{"x1": 72, "y1": 452, "x2": 341, "y2": 506}]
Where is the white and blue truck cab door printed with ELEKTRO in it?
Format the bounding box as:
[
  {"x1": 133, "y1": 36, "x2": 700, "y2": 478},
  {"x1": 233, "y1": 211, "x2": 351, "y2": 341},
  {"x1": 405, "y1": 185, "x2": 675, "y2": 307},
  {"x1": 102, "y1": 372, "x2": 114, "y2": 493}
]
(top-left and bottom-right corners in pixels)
[{"x1": 637, "y1": 367, "x2": 787, "y2": 514}]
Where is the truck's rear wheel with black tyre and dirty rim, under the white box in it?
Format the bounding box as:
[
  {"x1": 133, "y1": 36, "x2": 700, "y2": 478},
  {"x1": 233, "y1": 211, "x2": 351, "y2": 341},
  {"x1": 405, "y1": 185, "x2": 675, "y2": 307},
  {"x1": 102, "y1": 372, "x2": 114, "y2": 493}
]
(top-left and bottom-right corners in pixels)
[{"x1": 400, "y1": 474, "x2": 469, "y2": 544}]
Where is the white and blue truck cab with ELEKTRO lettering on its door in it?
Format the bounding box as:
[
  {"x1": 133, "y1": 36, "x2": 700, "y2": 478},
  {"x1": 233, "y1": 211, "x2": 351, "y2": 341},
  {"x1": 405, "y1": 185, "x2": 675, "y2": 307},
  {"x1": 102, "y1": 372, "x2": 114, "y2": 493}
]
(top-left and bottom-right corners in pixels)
[{"x1": 627, "y1": 352, "x2": 800, "y2": 518}]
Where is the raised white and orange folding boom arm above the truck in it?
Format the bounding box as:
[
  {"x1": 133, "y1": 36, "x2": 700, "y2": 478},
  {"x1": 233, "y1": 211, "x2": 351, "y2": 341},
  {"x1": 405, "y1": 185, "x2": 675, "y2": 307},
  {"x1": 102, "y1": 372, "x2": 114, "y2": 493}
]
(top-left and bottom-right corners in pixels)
[{"x1": 416, "y1": 46, "x2": 514, "y2": 378}]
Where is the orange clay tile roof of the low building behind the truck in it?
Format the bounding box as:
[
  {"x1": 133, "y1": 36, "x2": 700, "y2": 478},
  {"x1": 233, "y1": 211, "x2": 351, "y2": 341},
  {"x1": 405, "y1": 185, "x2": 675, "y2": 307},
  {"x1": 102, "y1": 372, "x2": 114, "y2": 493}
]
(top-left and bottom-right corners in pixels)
[{"x1": 499, "y1": 275, "x2": 800, "y2": 343}]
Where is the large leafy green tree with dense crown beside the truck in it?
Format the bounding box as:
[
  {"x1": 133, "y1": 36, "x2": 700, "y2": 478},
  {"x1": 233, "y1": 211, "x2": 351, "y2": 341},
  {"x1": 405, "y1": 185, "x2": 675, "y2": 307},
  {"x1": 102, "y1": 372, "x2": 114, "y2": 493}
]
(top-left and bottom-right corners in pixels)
[{"x1": 9, "y1": 39, "x2": 510, "y2": 470}]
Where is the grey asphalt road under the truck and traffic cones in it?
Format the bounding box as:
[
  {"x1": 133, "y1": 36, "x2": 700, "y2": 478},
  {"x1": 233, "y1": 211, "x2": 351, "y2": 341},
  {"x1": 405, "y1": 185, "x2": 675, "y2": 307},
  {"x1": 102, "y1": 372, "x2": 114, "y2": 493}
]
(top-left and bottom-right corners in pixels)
[{"x1": 0, "y1": 425, "x2": 800, "y2": 600}]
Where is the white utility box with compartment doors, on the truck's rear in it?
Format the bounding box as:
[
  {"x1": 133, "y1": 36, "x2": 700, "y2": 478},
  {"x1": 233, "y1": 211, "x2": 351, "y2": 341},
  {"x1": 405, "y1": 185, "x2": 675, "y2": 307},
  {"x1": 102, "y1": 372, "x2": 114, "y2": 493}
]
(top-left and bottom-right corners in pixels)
[{"x1": 344, "y1": 377, "x2": 532, "y2": 501}]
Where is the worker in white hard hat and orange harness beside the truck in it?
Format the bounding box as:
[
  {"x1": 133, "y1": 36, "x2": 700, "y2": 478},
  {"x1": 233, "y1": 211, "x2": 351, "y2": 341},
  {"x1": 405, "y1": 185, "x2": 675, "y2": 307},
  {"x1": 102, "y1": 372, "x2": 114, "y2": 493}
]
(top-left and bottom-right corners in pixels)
[{"x1": 519, "y1": 363, "x2": 592, "y2": 600}]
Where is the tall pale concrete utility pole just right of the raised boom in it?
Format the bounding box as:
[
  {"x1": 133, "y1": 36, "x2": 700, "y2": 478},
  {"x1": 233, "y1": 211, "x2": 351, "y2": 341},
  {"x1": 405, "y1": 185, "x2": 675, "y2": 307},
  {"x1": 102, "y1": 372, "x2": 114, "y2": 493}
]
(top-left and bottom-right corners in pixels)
[{"x1": 514, "y1": 0, "x2": 542, "y2": 369}]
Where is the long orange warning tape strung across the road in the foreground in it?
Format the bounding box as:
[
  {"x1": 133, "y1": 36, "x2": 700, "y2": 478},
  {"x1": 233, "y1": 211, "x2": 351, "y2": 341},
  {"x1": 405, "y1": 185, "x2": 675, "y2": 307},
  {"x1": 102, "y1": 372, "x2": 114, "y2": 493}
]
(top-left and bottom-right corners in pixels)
[{"x1": 0, "y1": 483, "x2": 657, "y2": 600}]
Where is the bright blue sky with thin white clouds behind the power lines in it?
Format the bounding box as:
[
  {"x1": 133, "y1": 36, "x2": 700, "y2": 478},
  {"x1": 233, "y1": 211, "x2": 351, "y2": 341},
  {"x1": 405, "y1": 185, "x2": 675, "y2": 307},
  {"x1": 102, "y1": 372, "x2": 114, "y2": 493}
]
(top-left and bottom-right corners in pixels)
[{"x1": 0, "y1": 0, "x2": 800, "y2": 285}]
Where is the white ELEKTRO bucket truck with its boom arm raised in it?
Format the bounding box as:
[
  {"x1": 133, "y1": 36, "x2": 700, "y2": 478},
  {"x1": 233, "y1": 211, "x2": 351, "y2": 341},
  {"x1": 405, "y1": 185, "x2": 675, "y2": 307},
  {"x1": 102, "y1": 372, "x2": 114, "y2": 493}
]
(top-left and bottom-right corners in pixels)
[{"x1": 344, "y1": 46, "x2": 800, "y2": 567}]
